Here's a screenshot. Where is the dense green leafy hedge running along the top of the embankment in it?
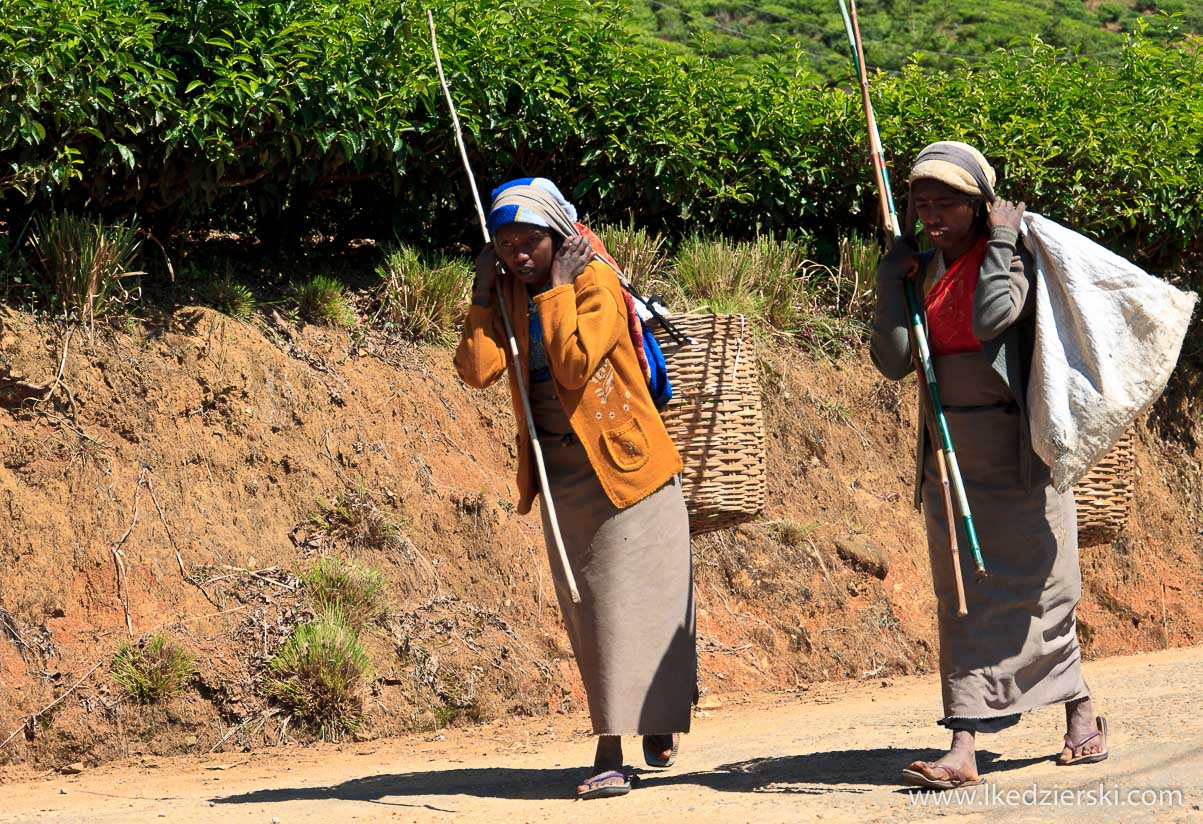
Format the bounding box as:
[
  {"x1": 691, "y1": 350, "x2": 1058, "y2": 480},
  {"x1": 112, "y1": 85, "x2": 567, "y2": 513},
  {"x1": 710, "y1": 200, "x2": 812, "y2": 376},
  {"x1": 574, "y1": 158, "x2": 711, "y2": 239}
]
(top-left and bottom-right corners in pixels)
[{"x1": 0, "y1": 0, "x2": 1203, "y2": 259}]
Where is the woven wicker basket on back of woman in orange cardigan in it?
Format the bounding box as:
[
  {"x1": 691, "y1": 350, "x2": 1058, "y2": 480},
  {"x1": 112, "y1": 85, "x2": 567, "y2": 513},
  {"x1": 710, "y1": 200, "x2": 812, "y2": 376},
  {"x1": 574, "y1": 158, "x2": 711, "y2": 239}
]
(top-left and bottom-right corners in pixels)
[{"x1": 657, "y1": 315, "x2": 765, "y2": 535}]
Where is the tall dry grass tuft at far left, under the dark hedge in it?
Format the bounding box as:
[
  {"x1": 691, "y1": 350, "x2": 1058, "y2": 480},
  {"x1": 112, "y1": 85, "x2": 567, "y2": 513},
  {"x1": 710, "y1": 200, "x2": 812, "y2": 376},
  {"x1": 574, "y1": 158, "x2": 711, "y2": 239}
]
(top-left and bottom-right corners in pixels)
[{"x1": 30, "y1": 213, "x2": 143, "y2": 326}]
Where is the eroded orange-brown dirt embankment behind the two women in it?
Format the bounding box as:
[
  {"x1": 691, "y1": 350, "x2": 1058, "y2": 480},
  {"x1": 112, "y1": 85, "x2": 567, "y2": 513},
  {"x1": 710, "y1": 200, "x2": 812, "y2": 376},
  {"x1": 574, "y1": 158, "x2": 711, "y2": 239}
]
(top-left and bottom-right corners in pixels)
[{"x1": 0, "y1": 309, "x2": 1203, "y2": 766}]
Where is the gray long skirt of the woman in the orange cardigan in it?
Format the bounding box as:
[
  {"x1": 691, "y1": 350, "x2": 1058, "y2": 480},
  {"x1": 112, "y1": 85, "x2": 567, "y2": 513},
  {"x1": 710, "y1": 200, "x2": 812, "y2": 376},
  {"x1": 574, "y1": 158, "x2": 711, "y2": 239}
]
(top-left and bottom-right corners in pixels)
[{"x1": 540, "y1": 438, "x2": 698, "y2": 735}]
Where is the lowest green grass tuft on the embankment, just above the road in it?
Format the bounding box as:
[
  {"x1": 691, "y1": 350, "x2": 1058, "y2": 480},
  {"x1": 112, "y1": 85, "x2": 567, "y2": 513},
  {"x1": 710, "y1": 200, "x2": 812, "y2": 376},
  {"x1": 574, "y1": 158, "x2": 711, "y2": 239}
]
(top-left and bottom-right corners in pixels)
[{"x1": 263, "y1": 612, "x2": 371, "y2": 741}]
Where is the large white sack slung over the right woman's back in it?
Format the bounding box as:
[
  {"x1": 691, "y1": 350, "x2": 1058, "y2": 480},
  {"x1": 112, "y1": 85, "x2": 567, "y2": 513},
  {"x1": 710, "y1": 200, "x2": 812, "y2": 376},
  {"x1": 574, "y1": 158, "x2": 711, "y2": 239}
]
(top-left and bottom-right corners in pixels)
[{"x1": 1023, "y1": 212, "x2": 1196, "y2": 492}]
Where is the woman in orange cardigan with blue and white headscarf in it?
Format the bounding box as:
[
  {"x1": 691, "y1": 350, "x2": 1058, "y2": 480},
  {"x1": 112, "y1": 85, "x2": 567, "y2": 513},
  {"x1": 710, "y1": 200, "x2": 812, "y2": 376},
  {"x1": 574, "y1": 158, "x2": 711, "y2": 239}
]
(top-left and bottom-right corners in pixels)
[{"x1": 455, "y1": 178, "x2": 697, "y2": 799}]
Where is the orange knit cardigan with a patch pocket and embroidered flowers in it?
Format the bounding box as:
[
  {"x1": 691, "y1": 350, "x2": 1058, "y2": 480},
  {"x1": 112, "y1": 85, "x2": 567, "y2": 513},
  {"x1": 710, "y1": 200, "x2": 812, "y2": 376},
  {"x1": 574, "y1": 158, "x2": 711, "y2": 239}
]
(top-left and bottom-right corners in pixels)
[{"x1": 455, "y1": 260, "x2": 682, "y2": 514}]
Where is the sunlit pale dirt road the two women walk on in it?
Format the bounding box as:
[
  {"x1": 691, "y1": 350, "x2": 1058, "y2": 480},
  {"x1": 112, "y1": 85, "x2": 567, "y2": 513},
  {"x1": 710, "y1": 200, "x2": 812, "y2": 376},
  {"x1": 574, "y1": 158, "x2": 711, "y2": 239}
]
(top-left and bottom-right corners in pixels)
[{"x1": 0, "y1": 647, "x2": 1203, "y2": 824}]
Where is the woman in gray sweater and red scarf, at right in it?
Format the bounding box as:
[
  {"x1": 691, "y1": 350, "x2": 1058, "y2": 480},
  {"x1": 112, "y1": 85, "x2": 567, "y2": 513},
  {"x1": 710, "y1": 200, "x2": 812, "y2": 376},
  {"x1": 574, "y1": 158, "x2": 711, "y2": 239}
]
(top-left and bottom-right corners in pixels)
[{"x1": 871, "y1": 141, "x2": 1107, "y2": 789}]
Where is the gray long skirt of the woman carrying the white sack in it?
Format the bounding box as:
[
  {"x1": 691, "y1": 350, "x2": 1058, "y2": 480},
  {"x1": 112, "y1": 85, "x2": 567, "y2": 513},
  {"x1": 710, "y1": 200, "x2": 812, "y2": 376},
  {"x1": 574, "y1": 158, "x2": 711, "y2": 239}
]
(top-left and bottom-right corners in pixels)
[{"x1": 923, "y1": 381, "x2": 1089, "y2": 733}]
